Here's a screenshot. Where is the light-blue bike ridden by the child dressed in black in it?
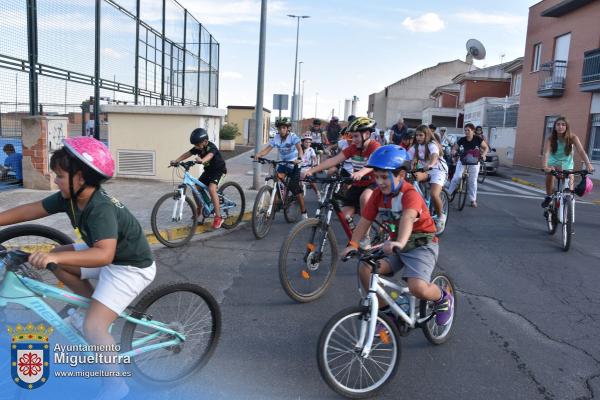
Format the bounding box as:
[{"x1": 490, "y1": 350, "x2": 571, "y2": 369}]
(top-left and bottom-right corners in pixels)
[{"x1": 150, "y1": 161, "x2": 246, "y2": 247}]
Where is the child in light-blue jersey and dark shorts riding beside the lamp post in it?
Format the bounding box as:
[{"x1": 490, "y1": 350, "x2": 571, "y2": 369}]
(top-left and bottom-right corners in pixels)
[{"x1": 254, "y1": 117, "x2": 308, "y2": 219}]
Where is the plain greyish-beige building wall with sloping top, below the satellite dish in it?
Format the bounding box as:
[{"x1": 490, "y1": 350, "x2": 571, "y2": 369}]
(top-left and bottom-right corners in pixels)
[{"x1": 374, "y1": 60, "x2": 473, "y2": 127}]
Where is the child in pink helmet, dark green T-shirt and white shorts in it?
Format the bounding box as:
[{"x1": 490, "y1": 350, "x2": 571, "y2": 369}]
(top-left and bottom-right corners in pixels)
[{"x1": 0, "y1": 137, "x2": 156, "y2": 399}]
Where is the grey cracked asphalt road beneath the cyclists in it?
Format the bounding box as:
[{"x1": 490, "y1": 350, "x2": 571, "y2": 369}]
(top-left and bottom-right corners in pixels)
[{"x1": 2, "y1": 177, "x2": 600, "y2": 400}]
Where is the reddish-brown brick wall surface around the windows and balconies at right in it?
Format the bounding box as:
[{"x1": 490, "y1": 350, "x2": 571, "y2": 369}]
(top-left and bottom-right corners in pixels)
[{"x1": 515, "y1": 0, "x2": 600, "y2": 168}]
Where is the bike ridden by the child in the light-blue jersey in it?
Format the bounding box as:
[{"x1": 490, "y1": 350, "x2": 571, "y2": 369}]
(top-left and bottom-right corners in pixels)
[{"x1": 250, "y1": 156, "x2": 301, "y2": 239}]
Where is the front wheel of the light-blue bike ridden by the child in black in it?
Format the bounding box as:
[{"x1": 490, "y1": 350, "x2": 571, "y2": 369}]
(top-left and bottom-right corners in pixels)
[{"x1": 150, "y1": 191, "x2": 198, "y2": 247}]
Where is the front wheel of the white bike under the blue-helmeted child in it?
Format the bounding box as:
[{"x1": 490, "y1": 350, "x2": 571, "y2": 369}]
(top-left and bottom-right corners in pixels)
[{"x1": 317, "y1": 307, "x2": 401, "y2": 399}]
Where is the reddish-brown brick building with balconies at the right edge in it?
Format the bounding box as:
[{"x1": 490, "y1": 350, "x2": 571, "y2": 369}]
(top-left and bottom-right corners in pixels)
[{"x1": 515, "y1": 0, "x2": 600, "y2": 168}]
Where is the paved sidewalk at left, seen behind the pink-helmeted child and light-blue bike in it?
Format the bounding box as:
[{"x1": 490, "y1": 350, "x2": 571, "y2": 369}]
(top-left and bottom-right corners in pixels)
[{"x1": 0, "y1": 150, "x2": 264, "y2": 244}]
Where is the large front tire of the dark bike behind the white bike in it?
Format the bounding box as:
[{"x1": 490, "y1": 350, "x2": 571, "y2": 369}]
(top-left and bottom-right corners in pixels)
[{"x1": 279, "y1": 218, "x2": 338, "y2": 303}]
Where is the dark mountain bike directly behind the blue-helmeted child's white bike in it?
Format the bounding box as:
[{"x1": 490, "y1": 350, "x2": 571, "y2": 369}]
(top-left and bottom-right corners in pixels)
[{"x1": 279, "y1": 176, "x2": 390, "y2": 303}]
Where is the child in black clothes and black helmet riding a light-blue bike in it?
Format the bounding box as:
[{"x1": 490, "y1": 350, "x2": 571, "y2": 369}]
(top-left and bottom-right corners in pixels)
[{"x1": 171, "y1": 128, "x2": 227, "y2": 229}]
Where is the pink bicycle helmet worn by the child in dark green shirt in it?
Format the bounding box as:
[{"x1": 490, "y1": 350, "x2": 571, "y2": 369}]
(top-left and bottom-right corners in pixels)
[{"x1": 63, "y1": 136, "x2": 115, "y2": 179}]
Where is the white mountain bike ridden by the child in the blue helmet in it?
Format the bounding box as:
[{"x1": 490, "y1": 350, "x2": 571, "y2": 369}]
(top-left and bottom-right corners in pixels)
[{"x1": 317, "y1": 249, "x2": 457, "y2": 399}]
